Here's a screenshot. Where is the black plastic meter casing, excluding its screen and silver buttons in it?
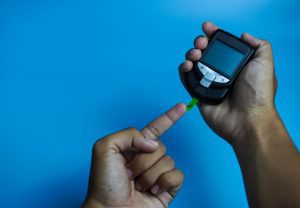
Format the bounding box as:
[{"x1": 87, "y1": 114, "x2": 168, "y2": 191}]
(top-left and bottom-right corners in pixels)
[{"x1": 180, "y1": 29, "x2": 255, "y2": 104}]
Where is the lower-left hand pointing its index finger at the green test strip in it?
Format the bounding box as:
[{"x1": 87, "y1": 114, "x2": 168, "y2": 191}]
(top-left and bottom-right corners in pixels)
[{"x1": 83, "y1": 104, "x2": 186, "y2": 208}]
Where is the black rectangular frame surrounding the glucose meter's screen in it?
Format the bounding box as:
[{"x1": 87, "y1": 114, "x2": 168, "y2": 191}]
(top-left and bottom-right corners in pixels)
[{"x1": 200, "y1": 29, "x2": 253, "y2": 79}]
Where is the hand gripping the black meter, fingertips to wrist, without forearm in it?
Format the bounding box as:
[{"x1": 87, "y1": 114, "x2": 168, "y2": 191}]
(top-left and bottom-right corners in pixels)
[{"x1": 179, "y1": 22, "x2": 277, "y2": 143}]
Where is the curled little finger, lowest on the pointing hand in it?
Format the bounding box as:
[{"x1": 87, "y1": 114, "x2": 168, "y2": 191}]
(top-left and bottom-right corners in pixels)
[{"x1": 151, "y1": 169, "x2": 184, "y2": 204}]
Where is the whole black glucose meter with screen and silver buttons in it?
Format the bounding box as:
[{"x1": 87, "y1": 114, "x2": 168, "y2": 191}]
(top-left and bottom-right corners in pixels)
[{"x1": 184, "y1": 29, "x2": 254, "y2": 104}]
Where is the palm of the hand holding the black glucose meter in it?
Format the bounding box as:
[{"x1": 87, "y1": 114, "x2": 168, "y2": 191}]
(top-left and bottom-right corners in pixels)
[{"x1": 199, "y1": 48, "x2": 274, "y2": 140}]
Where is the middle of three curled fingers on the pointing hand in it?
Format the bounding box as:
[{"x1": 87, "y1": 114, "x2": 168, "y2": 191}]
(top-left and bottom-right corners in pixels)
[{"x1": 136, "y1": 156, "x2": 175, "y2": 192}]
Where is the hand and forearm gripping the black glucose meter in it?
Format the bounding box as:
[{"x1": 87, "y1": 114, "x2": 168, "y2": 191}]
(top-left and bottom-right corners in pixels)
[{"x1": 179, "y1": 22, "x2": 300, "y2": 207}]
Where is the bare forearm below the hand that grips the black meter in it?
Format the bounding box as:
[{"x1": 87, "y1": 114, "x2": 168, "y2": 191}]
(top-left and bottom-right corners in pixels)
[{"x1": 232, "y1": 110, "x2": 300, "y2": 207}]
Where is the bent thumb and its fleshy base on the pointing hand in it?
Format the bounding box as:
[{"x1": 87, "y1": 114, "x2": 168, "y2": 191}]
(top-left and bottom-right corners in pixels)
[{"x1": 89, "y1": 128, "x2": 158, "y2": 207}]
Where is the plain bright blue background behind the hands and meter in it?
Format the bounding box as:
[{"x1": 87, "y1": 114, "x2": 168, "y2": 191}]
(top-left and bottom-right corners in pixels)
[{"x1": 0, "y1": 0, "x2": 300, "y2": 207}]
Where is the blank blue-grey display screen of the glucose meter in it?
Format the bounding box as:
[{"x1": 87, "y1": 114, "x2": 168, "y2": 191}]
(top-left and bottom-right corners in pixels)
[{"x1": 203, "y1": 40, "x2": 244, "y2": 78}]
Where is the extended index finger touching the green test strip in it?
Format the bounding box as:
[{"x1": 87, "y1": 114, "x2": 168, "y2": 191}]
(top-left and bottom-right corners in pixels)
[{"x1": 142, "y1": 103, "x2": 186, "y2": 139}]
